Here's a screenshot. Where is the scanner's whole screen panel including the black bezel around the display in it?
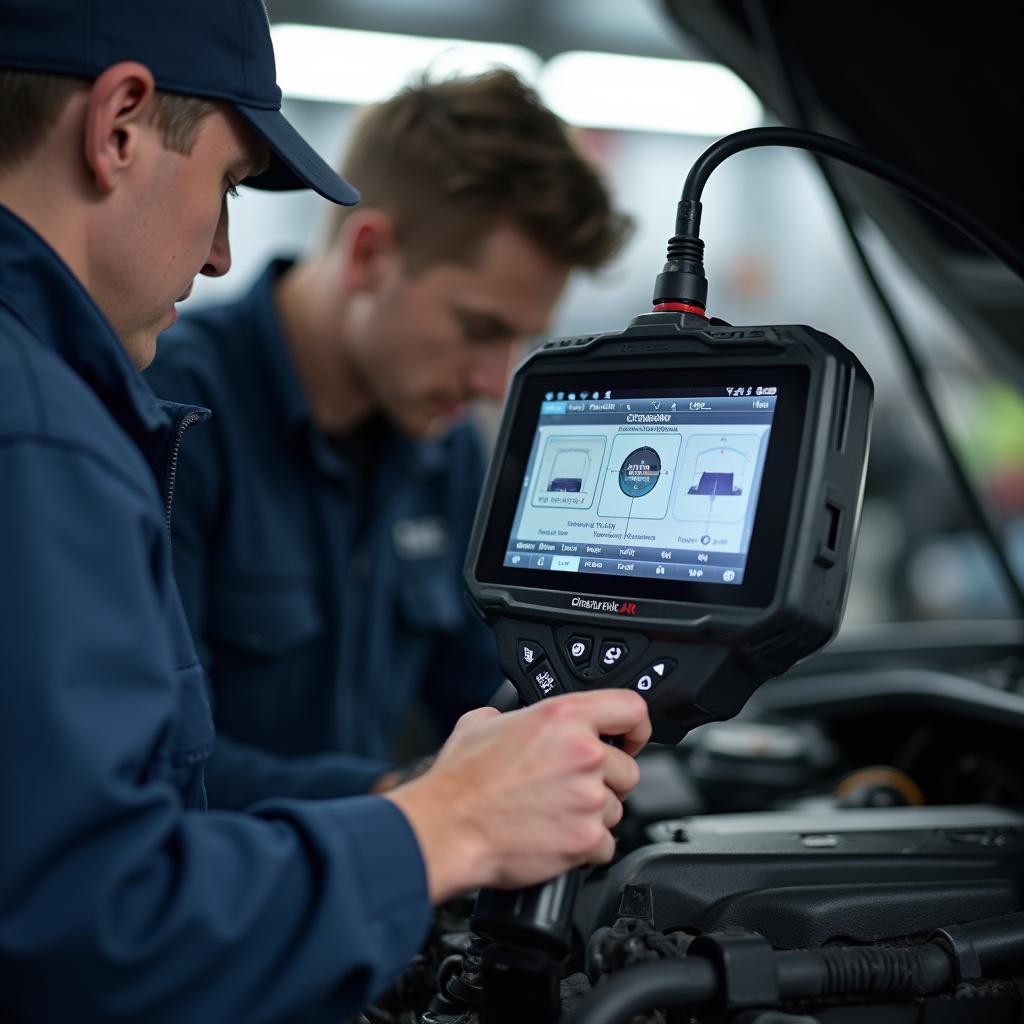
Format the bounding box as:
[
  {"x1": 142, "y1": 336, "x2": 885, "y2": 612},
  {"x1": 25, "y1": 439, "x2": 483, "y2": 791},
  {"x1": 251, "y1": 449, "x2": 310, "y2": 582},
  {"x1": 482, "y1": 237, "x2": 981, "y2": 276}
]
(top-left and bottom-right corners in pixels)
[{"x1": 477, "y1": 368, "x2": 807, "y2": 605}]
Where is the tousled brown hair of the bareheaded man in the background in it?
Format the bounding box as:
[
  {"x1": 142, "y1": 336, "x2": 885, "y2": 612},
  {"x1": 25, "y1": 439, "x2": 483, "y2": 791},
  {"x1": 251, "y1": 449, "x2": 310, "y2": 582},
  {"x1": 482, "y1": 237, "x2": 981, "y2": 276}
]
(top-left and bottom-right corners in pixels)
[{"x1": 328, "y1": 70, "x2": 632, "y2": 272}]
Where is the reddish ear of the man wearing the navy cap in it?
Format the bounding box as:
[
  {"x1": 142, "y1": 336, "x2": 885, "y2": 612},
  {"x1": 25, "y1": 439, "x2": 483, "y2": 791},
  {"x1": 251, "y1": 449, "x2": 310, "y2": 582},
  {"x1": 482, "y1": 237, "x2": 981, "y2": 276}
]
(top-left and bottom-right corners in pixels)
[{"x1": 83, "y1": 60, "x2": 157, "y2": 193}]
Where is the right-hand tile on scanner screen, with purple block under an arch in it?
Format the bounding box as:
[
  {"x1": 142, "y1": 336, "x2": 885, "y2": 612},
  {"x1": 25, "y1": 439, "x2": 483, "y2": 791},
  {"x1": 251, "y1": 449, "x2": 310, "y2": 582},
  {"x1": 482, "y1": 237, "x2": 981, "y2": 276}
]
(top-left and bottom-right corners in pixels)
[{"x1": 676, "y1": 433, "x2": 761, "y2": 532}]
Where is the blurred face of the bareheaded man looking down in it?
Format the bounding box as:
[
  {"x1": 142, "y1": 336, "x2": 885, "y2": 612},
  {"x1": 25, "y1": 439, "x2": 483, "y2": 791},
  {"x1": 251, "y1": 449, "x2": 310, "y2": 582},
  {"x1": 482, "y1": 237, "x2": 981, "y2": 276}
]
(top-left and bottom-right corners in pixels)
[{"x1": 347, "y1": 224, "x2": 569, "y2": 437}]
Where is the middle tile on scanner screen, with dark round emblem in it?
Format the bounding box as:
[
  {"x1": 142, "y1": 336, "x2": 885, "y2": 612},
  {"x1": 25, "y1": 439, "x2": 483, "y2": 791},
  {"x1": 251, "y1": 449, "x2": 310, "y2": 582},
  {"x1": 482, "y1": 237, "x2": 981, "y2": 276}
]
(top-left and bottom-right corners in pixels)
[{"x1": 597, "y1": 433, "x2": 679, "y2": 520}]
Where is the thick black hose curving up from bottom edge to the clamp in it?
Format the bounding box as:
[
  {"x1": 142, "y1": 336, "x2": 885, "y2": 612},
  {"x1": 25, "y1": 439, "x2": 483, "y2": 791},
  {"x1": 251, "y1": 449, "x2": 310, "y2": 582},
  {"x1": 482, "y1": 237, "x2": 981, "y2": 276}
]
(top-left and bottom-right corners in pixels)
[{"x1": 565, "y1": 957, "x2": 718, "y2": 1024}]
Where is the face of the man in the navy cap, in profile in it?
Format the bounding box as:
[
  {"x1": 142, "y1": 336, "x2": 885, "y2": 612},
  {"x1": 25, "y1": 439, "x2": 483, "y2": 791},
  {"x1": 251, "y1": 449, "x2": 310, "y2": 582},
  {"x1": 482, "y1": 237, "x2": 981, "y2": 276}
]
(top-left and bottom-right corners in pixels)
[{"x1": 90, "y1": 109, "x2": 262, "y2": 369}]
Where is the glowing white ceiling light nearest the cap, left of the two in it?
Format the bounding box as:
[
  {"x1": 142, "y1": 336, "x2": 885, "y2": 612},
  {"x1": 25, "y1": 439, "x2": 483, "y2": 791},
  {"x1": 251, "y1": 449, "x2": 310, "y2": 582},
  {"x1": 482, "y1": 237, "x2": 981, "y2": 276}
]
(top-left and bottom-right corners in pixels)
[{"x1": 272, "y1": 22, "x2": 541, "y2": 104}]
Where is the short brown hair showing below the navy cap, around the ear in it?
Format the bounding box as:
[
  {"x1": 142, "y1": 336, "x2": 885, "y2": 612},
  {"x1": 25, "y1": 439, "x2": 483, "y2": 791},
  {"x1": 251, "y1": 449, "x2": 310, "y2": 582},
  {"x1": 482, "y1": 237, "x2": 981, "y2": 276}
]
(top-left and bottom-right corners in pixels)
[{"x1": 0, "y1": 68, "x2": 217, "y2": 170}]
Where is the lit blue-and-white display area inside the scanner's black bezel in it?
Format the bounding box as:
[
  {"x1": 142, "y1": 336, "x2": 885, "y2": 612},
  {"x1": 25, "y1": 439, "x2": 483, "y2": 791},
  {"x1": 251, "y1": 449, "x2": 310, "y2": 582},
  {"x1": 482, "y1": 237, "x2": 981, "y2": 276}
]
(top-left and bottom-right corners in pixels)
[{"x1": 503, "y1": 384, "x2": 778, "y2": 586}]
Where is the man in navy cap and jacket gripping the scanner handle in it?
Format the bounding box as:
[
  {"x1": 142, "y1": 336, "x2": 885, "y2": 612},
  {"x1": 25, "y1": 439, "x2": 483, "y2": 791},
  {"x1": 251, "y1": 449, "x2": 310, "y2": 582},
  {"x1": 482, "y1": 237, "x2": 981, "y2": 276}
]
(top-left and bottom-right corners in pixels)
[{"x1": 0, "y1": 0, "x2": 649, "y2": 1022}]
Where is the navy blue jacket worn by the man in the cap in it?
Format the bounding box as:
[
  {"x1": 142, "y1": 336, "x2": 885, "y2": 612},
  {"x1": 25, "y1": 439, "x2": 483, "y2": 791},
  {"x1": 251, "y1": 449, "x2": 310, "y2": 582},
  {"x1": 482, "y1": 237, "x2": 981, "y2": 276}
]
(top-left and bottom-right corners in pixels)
[{"x1": 0, "y1": 208, "x2": 430, "y2": 1024}]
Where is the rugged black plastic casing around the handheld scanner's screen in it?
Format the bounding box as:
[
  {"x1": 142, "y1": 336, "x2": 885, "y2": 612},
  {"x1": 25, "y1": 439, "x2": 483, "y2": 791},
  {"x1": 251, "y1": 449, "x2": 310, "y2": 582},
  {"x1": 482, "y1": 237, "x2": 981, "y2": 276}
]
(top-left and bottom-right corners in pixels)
[{"x1": 464, "y1": 312, "x2": 873, "y2": 742}]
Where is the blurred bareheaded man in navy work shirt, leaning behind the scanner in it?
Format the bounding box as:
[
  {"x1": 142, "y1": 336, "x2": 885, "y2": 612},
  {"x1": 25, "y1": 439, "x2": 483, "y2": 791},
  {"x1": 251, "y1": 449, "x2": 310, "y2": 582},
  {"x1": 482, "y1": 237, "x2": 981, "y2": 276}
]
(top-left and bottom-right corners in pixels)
[{"x1": 146, "y1": 71, "x2": 625, "y2": 809}]
